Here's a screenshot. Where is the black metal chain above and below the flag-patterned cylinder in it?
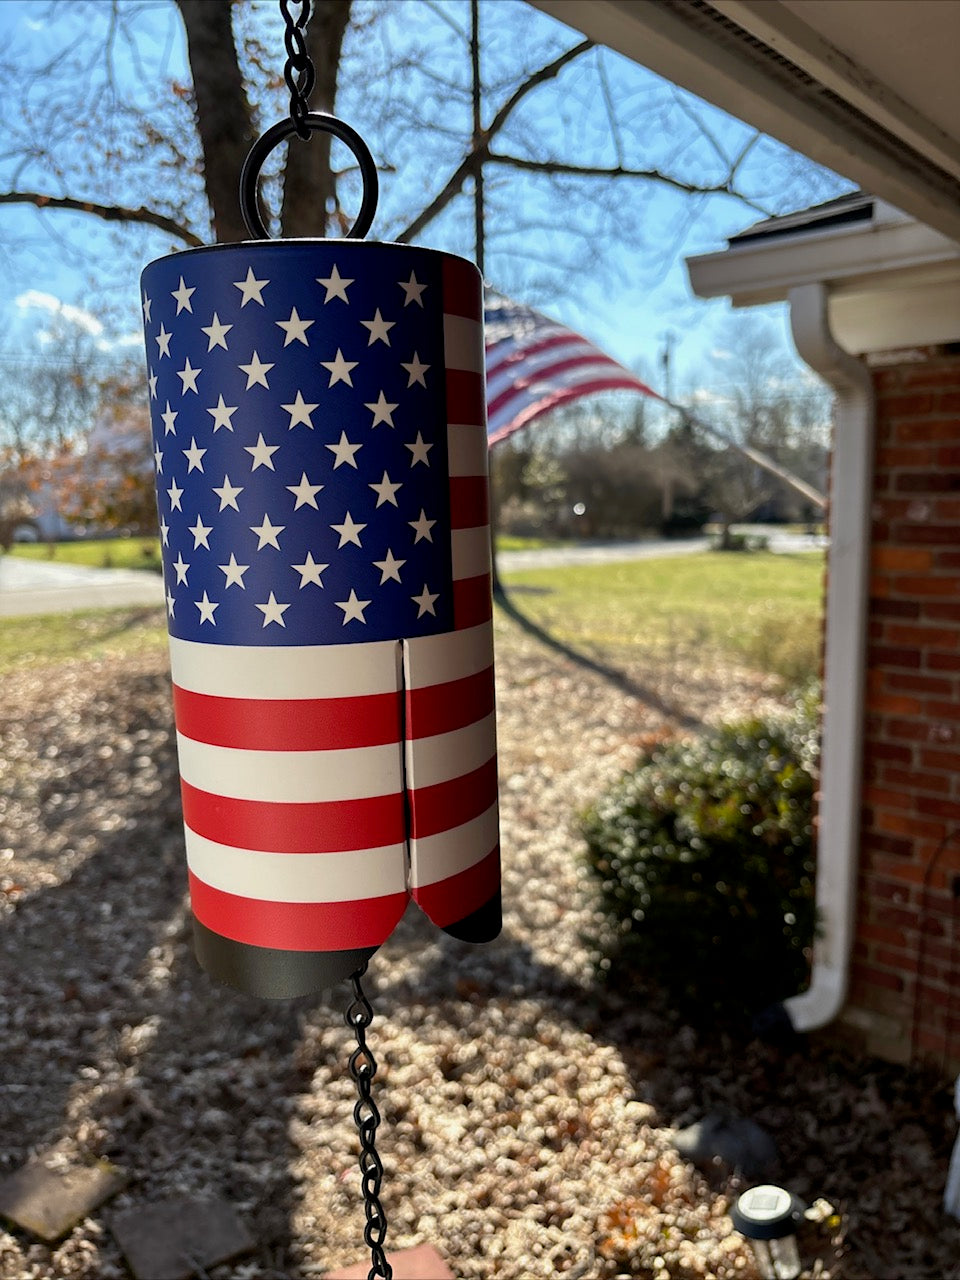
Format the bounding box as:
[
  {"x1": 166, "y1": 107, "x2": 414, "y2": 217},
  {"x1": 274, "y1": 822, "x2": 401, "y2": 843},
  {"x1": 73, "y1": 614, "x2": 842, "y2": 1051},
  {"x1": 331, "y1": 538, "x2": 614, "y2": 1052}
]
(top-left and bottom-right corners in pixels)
[{"x1": 277, "y1": 0, "x2": 393, "y2": 1280}]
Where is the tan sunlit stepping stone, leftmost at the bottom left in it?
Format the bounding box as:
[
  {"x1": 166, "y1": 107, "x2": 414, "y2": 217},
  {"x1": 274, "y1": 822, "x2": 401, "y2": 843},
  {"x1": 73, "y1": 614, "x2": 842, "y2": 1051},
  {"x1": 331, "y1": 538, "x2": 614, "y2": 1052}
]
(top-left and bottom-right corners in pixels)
[{"x1": 0, "y1": 1158, "x2": 127, "y2": 1242}]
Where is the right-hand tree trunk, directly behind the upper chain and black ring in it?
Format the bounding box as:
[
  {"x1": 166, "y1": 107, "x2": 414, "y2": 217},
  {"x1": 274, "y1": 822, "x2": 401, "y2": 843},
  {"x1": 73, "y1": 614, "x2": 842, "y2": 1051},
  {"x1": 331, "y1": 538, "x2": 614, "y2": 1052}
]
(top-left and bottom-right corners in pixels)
[{"x1": 281, "y1": 0, "x2": 351, "y2": 237}]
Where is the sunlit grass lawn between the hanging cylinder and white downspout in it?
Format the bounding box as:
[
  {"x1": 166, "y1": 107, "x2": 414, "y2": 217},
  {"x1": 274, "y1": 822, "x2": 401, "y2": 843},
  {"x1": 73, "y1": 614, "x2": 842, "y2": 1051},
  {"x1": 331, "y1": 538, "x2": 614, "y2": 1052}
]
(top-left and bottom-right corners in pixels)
[{"x1": 502, "y1": 552, "x2": 823, "y2": 682}]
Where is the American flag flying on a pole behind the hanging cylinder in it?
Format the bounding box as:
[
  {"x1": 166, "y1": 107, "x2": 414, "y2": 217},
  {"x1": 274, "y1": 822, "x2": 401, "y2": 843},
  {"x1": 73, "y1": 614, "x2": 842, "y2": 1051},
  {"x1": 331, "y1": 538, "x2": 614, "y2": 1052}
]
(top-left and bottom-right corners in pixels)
[{"x1": 484, "y1": 288, "x2": 660, "y2": 445}]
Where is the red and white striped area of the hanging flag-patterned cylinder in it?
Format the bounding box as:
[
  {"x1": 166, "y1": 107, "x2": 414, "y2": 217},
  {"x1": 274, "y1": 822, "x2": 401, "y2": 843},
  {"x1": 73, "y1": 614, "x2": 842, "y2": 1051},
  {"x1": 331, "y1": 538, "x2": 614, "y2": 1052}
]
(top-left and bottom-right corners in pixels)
[{"x1": 170, "y1": 265, "x2": 499, "y2": 951}]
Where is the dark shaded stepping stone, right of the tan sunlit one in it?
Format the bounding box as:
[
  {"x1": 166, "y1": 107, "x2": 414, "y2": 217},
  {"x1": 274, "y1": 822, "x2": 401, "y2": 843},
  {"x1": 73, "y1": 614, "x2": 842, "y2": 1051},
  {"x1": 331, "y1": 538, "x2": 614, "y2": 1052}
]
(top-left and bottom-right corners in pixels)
[{"x1": 110, "y1": 1196, "x2": 255, "y2": 1280}]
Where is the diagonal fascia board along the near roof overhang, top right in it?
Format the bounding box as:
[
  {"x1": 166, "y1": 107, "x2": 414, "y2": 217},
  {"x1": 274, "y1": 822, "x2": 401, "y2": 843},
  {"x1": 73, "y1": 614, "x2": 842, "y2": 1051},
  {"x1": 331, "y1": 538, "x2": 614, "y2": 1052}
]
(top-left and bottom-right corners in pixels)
[{"x1": 530, "y1": 0, "x2": 960, "y2": 241}]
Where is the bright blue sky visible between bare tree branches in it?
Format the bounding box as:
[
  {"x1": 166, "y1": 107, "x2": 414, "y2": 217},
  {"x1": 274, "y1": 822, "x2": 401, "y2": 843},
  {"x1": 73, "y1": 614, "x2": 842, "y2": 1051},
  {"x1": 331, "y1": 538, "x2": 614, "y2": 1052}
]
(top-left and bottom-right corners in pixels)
[{"x1": 0, "y1": 0, "x2": 849, "y2": 392}]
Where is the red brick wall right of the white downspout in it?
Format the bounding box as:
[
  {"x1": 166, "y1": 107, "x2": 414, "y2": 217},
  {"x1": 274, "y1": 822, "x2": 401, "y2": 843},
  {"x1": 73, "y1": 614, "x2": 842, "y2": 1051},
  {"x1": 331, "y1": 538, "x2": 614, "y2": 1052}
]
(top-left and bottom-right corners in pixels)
[{"x1": 845, "y1": 348, "x2": 960, "y2": 1070}]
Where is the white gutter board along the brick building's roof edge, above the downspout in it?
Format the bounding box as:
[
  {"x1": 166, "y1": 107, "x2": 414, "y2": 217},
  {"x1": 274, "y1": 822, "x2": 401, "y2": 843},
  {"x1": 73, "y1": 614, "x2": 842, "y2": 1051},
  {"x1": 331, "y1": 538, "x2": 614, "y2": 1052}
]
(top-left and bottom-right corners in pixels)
[{"x1": 686, "y1": 221, "x2": 960, "y2": 306}]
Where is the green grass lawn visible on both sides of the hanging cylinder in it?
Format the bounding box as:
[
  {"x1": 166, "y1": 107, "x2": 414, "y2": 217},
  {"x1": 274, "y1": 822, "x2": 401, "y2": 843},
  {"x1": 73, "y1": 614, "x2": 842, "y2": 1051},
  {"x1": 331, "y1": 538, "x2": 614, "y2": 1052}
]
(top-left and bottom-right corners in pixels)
[{"x1": 0, "y1": 550, "x2": 823, "y2": 684}]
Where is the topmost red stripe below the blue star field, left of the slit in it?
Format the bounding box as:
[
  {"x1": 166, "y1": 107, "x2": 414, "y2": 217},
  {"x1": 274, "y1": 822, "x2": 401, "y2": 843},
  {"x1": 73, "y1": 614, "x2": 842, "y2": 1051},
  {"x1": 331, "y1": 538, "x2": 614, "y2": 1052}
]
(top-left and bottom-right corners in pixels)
[{"x1": 173, "y1": 685, "x2": 401, "y2": 751}]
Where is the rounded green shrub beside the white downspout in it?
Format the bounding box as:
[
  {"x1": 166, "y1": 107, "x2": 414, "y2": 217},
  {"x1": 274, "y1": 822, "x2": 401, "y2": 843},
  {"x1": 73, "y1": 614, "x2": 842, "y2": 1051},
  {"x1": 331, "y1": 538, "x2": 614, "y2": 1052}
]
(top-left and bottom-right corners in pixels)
[{"x1": 581, "y1": 695, "x2": 818, "y2": 1016}]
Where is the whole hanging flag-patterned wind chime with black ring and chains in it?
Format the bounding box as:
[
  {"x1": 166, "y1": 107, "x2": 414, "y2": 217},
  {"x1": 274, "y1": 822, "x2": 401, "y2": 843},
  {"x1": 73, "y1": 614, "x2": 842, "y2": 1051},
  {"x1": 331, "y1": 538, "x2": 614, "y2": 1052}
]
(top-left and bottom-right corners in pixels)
[{"x1": 141, "y1": 0, "x2": 500, "y2": 1277}]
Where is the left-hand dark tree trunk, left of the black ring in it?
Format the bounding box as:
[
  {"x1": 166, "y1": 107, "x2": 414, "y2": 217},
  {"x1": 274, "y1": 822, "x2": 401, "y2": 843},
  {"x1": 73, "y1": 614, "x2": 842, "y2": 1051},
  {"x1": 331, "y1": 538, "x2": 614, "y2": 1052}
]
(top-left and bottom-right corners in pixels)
[{"x1": 177, "y1": 0, "x2": 253, "y2": 243}]
